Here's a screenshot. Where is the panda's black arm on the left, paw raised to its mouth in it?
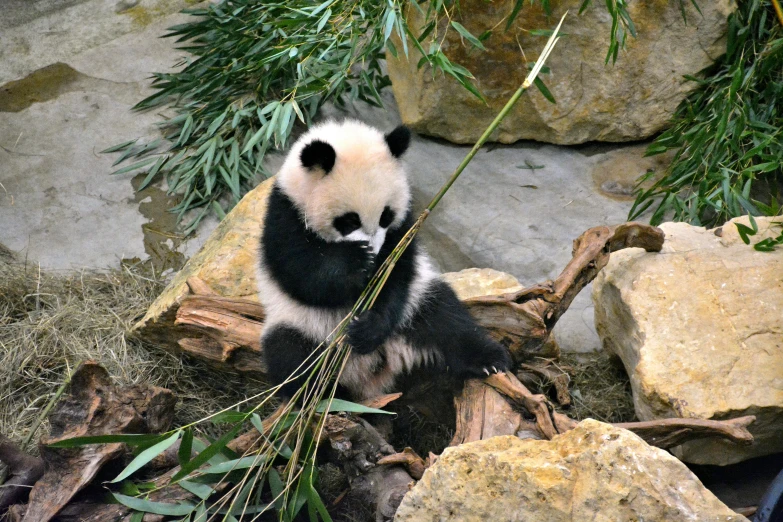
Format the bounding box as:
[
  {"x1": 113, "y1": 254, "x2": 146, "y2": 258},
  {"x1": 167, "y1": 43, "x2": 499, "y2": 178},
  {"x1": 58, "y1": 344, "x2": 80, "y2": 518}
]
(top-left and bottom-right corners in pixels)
[{"x1": 261, "y1": 187, "x2": 374, "y2": 307}]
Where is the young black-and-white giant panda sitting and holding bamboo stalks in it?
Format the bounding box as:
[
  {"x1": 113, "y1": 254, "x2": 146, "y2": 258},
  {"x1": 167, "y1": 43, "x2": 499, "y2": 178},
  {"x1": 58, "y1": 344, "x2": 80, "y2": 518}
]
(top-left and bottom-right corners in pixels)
[{"x1": 257, "y1": 120, "x2": 511, "y2": 400}]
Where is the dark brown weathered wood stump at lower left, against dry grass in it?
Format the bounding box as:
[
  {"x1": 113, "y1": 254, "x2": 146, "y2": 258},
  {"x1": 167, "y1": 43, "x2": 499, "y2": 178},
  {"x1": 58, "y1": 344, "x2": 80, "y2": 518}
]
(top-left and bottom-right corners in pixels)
[{"x1": 17, "y1": 361, "x2": 175, "y2": 522}]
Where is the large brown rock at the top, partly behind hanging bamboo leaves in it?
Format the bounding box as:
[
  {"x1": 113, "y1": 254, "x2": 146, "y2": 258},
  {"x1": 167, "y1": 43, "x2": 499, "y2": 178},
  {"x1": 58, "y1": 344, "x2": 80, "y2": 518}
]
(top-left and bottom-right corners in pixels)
[{"x1": 388, "y1": 0, "x2": 735, "y2": 144}]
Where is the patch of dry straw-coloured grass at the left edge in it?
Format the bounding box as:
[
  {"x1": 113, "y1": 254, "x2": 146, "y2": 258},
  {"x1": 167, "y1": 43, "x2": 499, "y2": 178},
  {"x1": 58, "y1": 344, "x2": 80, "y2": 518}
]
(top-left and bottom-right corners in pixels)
[{"x1": 0, "y1": 253, "x2": 262, "y2": 441}]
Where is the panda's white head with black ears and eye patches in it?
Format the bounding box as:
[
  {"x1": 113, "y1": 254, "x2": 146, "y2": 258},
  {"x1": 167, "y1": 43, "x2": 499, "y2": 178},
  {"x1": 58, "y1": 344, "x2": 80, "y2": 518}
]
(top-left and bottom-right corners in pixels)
[{"x1": 277, "y1": 120, "x2": 410, "y2": 254}]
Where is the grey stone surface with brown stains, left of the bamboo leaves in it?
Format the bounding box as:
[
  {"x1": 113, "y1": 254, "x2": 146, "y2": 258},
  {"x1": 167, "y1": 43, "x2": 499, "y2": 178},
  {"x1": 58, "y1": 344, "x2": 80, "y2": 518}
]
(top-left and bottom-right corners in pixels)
[{"x1": 0, "y1": 4, "x2": 214, "y2": 270}]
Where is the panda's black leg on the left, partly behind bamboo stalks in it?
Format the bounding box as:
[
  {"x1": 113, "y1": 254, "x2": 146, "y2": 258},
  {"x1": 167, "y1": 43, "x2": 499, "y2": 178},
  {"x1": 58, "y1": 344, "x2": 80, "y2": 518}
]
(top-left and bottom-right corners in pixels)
[{"x1": 261, "y1": 325, "x2": 318, "y2": 399}]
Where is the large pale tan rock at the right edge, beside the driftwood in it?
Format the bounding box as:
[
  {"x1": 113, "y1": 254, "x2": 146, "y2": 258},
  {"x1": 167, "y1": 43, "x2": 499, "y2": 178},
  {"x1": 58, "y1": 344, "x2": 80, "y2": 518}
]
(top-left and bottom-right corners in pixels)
[{"x1": 593, "y1": 218, "x2": 783, "y2": 465}]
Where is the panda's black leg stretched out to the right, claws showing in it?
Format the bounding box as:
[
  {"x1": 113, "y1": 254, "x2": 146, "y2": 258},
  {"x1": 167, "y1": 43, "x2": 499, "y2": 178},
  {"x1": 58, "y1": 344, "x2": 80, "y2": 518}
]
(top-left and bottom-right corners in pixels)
[{"x1": 405, "y1": 282, "x2": 511, "y2": 379}]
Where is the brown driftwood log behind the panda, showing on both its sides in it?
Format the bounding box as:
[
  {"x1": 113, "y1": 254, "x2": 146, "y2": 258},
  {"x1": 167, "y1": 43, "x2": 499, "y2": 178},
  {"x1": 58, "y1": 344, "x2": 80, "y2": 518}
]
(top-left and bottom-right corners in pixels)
[{"x1": 161, "y1": 223, "x2": 663, "y2": 373}]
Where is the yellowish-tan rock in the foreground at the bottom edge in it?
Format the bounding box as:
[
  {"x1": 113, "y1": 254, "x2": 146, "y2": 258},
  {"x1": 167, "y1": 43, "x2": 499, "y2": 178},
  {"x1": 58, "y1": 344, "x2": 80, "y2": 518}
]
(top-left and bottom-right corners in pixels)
[{"x1": 394, "y1": 419, "x2": 747, "y2": 522}]
